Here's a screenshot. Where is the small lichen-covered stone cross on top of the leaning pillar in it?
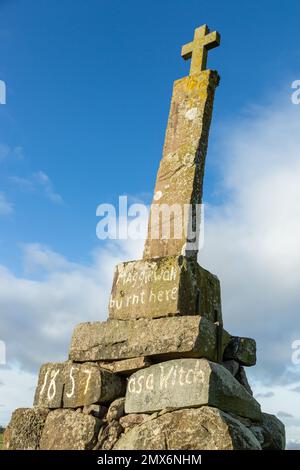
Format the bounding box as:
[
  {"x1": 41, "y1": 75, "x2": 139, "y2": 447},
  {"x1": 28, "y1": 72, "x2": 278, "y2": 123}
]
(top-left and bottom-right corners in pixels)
[{"x1": 181, "y1": 24, "x2": 220, "y2": 75}]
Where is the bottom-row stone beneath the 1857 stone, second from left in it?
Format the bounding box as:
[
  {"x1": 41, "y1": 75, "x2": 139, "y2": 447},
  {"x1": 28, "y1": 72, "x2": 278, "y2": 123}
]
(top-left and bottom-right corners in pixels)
[{"x1": 40, "y1": 410, "x2": 100, "y2": 450}]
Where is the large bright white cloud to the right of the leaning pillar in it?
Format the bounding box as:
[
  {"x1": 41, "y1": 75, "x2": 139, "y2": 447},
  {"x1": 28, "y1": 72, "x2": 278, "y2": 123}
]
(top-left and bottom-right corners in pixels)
[{"x1": 199, "y1": 99, "x2": 300, "y2": 379}]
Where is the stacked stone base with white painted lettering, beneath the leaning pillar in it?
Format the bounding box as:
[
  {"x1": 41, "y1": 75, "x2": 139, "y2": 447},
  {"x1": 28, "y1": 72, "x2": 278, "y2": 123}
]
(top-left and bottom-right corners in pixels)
[{"x1": 4, "y1": 257, "x2": 285, "y2": 450}]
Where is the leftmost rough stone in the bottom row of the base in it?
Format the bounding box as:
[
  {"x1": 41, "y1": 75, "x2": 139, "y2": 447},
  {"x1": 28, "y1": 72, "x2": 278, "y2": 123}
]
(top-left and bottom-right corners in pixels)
[{"x1": 3, "y1": 408, "x2": 49, "y2": 450}]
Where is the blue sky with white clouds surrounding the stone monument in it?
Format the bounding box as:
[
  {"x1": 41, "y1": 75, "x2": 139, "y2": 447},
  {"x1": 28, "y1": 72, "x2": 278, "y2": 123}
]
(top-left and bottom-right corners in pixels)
[{"x1": 0, "y1": 0, "x2": 300, "y2": 446}]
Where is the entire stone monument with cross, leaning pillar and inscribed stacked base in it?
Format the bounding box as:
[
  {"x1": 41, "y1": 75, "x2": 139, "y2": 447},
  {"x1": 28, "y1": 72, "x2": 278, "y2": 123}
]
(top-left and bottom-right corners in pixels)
[{"x1": 4, "y1": 25, "x2": 285, "y2": 450}]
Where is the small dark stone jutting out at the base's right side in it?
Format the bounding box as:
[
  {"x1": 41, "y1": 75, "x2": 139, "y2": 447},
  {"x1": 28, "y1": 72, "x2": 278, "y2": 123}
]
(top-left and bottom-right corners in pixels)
[{"x1": 224, "y1": 336, "x2": 256, "y2": 366}]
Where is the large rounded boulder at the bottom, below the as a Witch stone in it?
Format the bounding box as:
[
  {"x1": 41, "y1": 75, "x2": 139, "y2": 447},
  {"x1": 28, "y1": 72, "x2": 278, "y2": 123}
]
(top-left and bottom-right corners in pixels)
[{"x1": 114, "y1": 406, "x2": 261, "y2": 450}]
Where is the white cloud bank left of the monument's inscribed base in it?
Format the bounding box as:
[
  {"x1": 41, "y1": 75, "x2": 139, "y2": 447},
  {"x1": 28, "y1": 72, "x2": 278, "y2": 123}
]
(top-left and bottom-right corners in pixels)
[{"x1": 0, "y1": 242, "x2": 142, "y2": 371}]
